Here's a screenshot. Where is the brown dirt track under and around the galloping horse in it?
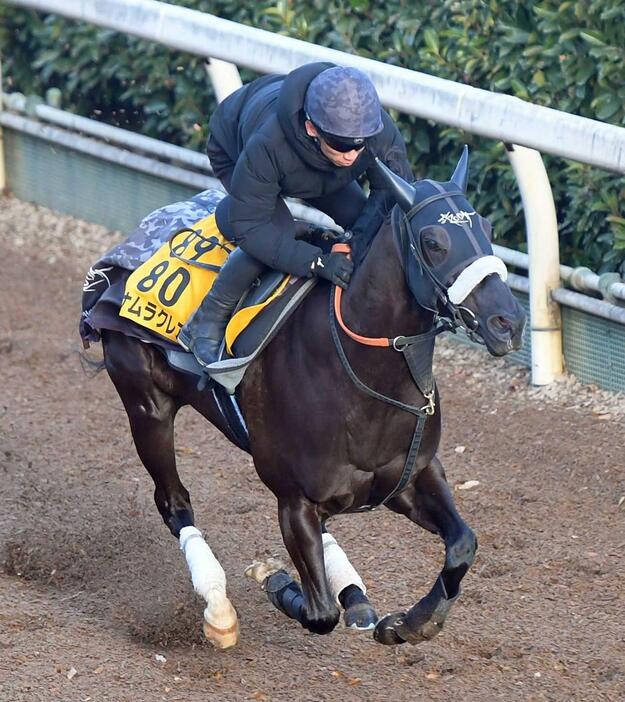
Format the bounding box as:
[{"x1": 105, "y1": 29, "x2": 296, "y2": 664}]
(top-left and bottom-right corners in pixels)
[{"x1": 0, "y1": 198, "x2": 625, "y2": 702}]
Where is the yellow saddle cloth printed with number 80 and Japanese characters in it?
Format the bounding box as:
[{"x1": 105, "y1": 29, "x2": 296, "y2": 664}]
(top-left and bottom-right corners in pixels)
[{"x1": 119, "y1": 214, "x2": 290, "y2": 352}]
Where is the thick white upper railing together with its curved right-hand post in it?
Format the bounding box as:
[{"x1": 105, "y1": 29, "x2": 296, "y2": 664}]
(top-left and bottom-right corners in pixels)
[{"x1": 5, "y1": 0, "x2": 625, "y2": 384}]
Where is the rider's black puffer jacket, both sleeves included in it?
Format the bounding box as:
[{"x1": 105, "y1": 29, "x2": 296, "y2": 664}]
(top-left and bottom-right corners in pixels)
[{"x1": 209, "y1": 63, "x2": 413, "y2": 275}]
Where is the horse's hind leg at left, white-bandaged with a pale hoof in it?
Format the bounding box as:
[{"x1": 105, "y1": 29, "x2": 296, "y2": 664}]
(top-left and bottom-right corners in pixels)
[{"x1": 103, "y1": 333, "x2": 239, "y2": 648}]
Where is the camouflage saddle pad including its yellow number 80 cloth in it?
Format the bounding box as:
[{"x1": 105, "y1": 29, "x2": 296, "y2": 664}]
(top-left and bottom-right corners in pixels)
[{"x1": 80, "y1": 190, "x2": 316, "y2": 393}]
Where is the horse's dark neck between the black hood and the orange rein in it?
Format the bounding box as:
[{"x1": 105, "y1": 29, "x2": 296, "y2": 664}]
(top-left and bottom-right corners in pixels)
[{"x1": 343, "y1": 223, "x2": 433, "y2": 337}]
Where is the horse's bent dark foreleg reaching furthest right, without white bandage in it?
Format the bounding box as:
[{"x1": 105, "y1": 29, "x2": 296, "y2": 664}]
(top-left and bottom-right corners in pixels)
[{"x1": 374, "y1": 458, "x2": 477, "y2": 644}]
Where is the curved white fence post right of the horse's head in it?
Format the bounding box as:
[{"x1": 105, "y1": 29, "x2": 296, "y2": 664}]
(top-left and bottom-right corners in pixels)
[{"x1": 506, "y1": 144, "x2": 563, "y2": 385}]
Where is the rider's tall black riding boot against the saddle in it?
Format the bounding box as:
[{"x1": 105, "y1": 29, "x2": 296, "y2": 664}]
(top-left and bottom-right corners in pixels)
[{"x1": 178, "y1": 249, "x2": 265, "y2": 366}]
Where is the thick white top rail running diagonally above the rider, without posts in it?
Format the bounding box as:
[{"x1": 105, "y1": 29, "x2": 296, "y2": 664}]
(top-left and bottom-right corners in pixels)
[{"x1": 4, "y1": 0, "x2": 625, "y2": 173}]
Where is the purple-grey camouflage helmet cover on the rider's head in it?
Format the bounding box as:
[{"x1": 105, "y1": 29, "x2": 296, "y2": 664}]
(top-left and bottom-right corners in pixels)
[{"x1": 304, "y1": 66, "x2": 384, "y2": 139}]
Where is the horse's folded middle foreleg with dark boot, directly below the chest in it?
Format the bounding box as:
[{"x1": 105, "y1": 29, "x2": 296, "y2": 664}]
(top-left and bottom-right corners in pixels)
[{"x1": 265, "y1": 499, "x2": 339, "y2": 634}]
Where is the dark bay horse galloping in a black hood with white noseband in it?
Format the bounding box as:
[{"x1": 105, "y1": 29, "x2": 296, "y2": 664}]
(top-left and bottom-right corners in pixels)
[{"x1": 102, "y1": 149, "x2": 525, "y2": 648}]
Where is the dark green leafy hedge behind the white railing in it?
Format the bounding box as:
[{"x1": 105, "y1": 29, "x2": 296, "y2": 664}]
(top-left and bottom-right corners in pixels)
[{"x1": 0, "y1": 0, "x2": 625, "y2": 271}]
